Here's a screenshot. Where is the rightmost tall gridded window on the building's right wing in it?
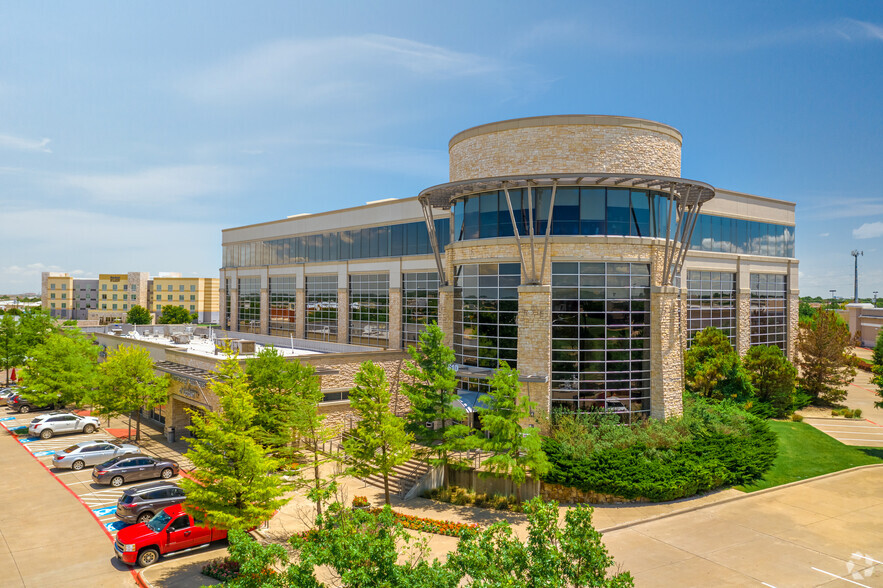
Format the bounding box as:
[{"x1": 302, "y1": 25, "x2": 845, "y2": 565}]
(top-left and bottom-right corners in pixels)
[{"x1": 751, "y1": 274, "x2": 788, "y2": 353}]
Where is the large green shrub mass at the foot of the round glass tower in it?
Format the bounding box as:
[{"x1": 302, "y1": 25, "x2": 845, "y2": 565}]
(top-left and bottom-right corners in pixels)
[{"x1": 543, "y1": 399, "x2": 776, "y2": 501}]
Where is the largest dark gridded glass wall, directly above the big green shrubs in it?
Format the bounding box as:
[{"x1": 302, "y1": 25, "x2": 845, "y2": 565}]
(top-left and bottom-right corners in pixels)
[{"x1": 551, "y1": 262, "x2": 650, "y2": 422}]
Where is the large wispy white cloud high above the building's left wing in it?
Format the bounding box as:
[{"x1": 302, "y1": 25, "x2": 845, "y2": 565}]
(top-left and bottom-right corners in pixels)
[{"x1": 183, "y1": 35, "x2": 505, "y2": 105}]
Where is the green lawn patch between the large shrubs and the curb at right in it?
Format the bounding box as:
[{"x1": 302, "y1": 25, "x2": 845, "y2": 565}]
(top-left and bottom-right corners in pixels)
[{"x1": 736, "y1": 421, "x2": 883, "y2": 492}]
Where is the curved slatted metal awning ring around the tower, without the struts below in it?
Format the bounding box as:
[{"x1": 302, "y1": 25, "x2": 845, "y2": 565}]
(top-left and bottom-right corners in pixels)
[{"x1": 417, "y1": 173, "x2": 714, "y2": 210}]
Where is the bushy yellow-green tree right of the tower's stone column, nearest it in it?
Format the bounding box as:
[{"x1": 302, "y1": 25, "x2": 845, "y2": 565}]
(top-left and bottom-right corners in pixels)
[{"x1": 684, "y1": 327, "x2": 753, "y2": 401}]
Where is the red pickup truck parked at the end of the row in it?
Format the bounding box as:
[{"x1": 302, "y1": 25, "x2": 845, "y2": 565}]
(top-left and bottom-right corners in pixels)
[{"x1": 113, "y1": 504, "x2": 227, "y2": 568}]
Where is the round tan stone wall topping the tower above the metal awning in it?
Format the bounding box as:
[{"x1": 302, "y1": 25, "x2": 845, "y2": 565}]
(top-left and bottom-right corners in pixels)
[{"x1": 449, "y1": 117, "x2": 681, "y2": 182}]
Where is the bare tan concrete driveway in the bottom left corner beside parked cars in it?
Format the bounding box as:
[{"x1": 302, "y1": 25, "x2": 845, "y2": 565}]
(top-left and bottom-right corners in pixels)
[{"x1": 0, "y1": 420, "x2": 137, "y2": 588}]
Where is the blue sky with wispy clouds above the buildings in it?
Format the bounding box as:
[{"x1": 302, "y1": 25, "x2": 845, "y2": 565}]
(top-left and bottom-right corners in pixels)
[{"x1": 0, "y1": 0, "x2": 883, "y2": 297}]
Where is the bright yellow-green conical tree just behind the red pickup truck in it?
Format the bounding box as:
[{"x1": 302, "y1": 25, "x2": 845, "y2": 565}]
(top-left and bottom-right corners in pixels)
[{"x1": 181, "y1": 349, "x2": 285, "y2": 530}]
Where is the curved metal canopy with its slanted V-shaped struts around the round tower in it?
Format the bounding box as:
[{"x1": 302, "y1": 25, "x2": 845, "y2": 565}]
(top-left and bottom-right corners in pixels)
[{"x1": 417, "y1": 174, "x2": 714, "y2": 286}]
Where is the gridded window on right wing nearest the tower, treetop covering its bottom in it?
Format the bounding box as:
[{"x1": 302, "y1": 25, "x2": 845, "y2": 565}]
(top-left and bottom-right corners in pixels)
[{"x1": 687, "y1": 271, "x2": 736, "y2": 348}]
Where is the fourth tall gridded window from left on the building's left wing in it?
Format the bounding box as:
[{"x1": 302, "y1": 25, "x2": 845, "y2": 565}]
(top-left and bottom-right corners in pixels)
[{"x1": 349, "y1": 274, "x2": 389, "y2": 347}]
